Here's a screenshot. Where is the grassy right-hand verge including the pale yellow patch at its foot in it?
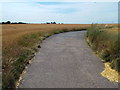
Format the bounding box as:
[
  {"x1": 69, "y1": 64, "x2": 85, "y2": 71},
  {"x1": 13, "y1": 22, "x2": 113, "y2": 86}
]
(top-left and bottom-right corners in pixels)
[{"x1": 87, "y1": 24, "x2": 120, "y2": 82}]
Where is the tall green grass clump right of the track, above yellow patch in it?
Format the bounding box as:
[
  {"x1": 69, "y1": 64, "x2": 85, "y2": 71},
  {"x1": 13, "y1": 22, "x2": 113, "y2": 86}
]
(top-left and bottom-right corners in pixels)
[{"x1": 86, "y1": 24, "x2": 120, "y2": 72}]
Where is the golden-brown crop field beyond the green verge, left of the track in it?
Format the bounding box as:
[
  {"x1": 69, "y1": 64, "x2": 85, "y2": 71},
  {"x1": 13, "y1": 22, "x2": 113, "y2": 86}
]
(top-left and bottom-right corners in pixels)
[{"x1": 2, "y1": 24, "x2": 90, "y2": 48}]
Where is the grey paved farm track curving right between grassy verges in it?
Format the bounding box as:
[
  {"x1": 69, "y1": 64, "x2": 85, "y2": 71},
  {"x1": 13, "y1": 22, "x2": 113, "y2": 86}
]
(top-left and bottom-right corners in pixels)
[{"x1": 19, "y1": 31, "x2": 118, "y2": 88}]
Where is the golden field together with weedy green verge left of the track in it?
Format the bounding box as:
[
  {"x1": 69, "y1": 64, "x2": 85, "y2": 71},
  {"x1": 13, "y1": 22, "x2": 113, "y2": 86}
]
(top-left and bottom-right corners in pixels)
[{"x1": 2, "y1": 24, "x2": 90, "y2": 89}]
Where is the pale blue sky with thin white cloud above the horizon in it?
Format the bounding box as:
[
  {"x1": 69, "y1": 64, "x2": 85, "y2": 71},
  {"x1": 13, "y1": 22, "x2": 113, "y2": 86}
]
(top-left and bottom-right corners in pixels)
[{"x1": 0, "y1": 0, "x2": 118, "y2": 24}]
